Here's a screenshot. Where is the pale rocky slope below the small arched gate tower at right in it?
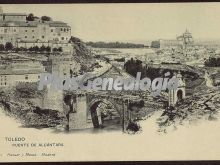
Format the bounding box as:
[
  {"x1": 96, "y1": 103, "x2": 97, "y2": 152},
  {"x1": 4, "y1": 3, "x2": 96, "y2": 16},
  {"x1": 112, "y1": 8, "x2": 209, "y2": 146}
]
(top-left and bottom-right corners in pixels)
[{"x1": 157, "y1": 87, "x2": 220, "y2": 132}]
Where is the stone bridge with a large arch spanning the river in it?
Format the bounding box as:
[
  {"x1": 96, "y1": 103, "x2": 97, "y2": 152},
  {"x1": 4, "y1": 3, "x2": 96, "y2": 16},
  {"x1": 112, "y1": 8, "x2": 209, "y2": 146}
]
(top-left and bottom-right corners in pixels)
[{"x1": 67, "y1": 91, "x2": 140, "y2": 131}]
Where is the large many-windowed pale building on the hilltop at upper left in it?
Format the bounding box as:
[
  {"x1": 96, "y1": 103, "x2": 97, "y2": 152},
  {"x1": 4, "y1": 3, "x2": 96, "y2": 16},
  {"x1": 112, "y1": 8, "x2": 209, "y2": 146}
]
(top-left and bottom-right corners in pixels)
[{"x1": 0, "y1": 6, "x2": 73, "y2": 52}]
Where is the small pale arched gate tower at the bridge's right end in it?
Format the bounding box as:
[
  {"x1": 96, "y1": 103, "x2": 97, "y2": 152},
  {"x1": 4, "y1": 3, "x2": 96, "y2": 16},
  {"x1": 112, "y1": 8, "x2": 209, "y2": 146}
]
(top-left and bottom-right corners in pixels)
[{"x1": 169, "y1": 71, "x2": 186, "y2": 106}]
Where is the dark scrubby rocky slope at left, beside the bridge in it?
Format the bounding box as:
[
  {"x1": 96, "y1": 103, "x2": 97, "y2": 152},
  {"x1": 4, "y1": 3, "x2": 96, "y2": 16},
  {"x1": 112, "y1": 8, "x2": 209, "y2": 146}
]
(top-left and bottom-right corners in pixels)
[{"x1": 0, "y1": 83, "x2": 66, "y2": 128}]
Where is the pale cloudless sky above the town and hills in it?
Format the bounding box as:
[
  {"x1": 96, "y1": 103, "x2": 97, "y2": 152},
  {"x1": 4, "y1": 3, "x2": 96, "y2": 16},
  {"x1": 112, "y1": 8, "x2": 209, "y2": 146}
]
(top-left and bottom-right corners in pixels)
[{"x1": 1, "y1": 3, "x2": 220, "y2": 42}]
